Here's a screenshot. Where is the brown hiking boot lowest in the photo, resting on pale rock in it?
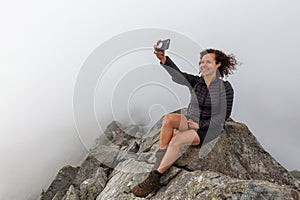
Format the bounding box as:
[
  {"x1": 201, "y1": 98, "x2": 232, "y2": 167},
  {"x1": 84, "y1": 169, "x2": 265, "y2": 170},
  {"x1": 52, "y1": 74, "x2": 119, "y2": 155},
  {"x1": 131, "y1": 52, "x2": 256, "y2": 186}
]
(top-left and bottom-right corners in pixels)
[{"x1": 131, "y1": 171, "x2": 161, "y2": 197}]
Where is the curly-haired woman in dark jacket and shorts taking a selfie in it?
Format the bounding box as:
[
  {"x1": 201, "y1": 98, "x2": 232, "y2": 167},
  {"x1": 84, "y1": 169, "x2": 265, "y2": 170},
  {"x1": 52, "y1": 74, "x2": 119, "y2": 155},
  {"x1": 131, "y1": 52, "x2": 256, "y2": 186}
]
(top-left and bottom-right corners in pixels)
[{"x1": 132, "y1": 42, "x2": 237, "y2": 197}]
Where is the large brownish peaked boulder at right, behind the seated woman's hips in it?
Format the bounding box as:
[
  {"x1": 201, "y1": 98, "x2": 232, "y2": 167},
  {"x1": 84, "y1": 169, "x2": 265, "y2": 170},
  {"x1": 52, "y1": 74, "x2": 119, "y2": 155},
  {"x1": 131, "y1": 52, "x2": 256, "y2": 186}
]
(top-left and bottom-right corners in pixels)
[{"x1": 176, "y1": 121, "x2": 299, "y2": 190}]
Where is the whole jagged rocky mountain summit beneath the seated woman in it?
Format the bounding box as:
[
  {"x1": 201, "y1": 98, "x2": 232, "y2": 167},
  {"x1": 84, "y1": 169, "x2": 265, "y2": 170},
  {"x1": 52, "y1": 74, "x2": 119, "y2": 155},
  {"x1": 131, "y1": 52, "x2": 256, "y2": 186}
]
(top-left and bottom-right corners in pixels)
[{"x1": 40, "y1": 109, "x2": 300, "y2": 200}]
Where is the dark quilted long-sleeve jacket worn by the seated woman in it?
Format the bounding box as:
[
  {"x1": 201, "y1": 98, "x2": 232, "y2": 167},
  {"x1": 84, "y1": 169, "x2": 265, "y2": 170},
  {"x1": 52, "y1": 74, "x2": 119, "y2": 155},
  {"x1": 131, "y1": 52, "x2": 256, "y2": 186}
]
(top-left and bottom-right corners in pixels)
[{"x1": 161, "y1": 56, "x2": 234, "y2": 130}]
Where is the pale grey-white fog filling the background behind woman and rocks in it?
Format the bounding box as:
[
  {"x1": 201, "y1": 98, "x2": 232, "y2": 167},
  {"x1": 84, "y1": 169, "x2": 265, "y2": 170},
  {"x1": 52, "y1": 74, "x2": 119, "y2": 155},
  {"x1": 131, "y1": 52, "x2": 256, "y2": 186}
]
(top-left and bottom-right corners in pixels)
[{"x1": 0, "y1": 0, "x2": 300, "y2": 199}]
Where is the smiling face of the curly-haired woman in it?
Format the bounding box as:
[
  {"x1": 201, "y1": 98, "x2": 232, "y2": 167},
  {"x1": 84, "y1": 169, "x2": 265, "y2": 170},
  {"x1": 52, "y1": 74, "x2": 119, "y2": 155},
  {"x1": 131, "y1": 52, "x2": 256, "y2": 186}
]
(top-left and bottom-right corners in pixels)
[{"x1": 200, "y1": 53, "x2": 221, "y2": 77}]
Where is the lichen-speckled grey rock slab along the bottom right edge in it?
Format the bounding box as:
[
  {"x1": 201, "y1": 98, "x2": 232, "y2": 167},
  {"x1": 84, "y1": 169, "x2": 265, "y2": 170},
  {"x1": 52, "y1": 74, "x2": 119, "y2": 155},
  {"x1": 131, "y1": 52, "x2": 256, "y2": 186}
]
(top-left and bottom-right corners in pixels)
[{"x1": 151, "y1": 170, "x2": 300, "y2": 200}]
